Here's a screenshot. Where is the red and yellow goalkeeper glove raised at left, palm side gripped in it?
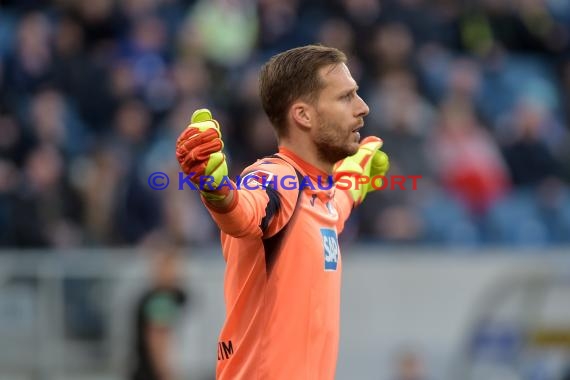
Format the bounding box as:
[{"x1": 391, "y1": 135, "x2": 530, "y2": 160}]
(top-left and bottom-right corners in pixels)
[{"x1": 176, "y1": 109, "x2": 231, "y2": 201}]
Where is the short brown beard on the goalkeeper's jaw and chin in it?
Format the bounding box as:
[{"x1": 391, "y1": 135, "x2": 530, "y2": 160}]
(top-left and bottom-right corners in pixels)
[{"x1": 315, "y1": 117, "x2": 358, "y2": 164}]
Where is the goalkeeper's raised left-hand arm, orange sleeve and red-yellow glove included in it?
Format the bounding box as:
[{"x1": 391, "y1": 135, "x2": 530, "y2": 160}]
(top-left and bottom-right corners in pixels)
[{"x1": 176, "y1": 109, "x2": 297, "y2": 237}]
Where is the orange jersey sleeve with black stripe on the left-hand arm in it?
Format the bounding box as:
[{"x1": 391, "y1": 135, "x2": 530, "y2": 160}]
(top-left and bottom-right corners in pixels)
[{"x1": 204, "y1": 158, "x2": 299, "y2": 238}]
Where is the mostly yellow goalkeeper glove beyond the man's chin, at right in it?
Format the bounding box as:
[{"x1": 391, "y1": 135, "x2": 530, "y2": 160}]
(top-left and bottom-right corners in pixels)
[{"x1": 333, "y1": 136, "x2": 390, "y2": 205}]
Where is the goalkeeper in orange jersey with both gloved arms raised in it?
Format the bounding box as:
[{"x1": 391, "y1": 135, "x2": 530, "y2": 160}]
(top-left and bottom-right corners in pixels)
[{"x1": 176, "y1": 45, "x2": 389, "y2": 380}]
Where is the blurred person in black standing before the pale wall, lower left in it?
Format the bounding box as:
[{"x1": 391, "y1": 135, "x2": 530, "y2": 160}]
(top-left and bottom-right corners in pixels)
[{"x1": 129, "y1": 238, "x2": 187, "y2": 380}]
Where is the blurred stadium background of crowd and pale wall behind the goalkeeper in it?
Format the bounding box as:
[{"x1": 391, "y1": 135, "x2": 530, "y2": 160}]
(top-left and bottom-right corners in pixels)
[{"x1": 0, "y1": 0, "x2": 570, "y2": 380}]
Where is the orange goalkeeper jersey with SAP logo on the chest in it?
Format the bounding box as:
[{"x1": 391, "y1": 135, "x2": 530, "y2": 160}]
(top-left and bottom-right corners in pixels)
[{"x1": 202, "y1": 148, "x2": 353, "y2": 380}]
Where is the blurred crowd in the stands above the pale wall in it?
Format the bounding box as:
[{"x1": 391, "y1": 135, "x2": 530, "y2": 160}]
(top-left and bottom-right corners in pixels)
[{"x1": 0, "y1": 0, "x2": 570, "y2": 248}]
